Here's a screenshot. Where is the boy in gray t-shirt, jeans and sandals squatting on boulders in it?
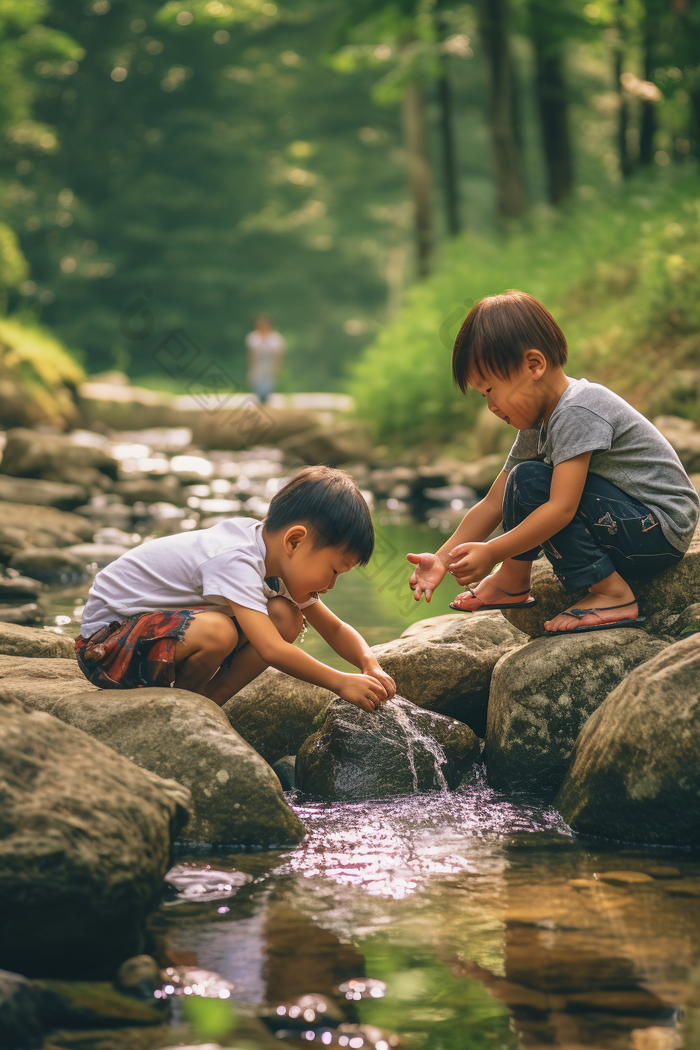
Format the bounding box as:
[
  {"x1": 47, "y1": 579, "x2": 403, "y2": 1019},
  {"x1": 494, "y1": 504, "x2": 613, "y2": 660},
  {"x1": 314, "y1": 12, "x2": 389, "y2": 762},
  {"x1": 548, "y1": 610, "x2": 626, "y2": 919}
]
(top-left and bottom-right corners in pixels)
[{"x1": 408, "y1": 292, "x2": 699, "y2": 634}]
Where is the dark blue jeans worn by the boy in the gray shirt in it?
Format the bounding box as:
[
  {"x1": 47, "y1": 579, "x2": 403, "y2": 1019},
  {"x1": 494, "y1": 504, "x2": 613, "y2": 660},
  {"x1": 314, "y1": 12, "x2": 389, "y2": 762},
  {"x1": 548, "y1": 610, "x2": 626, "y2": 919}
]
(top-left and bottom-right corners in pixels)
[{"x1": 503, "y1": 460, "x2": 683, "y2": 592}]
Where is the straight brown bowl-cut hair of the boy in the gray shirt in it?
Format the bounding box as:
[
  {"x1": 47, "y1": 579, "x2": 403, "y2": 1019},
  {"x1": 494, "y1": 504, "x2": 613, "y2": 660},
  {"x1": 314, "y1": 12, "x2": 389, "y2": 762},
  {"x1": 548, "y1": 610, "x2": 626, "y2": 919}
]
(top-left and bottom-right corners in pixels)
[{"x1": 452, "y1": 290, "x2": 569, "y2": 394}]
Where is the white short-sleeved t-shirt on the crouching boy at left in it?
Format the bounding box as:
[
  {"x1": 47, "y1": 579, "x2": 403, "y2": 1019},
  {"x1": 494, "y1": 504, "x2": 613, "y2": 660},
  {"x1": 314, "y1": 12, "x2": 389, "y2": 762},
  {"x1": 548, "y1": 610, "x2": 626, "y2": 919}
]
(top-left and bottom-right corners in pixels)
[{"x1": 81, "y1": 518, "x2": 318, "y2": 638}]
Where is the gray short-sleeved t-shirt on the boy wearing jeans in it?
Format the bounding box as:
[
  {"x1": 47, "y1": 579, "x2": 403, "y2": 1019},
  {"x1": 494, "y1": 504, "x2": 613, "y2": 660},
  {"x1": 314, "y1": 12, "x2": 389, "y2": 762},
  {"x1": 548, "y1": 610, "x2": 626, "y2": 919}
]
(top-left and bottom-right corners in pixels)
[{"x1": 504, "y1": 379, "x2": 700, "y2": 552}]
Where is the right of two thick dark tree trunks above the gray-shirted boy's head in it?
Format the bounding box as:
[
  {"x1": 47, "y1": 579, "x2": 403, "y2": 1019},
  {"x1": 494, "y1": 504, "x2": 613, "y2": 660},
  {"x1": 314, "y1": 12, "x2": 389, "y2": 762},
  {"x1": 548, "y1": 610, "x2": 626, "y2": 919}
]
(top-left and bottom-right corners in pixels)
[{"x1": 530, "y1": 0, "x2": 573, "y2": 205}]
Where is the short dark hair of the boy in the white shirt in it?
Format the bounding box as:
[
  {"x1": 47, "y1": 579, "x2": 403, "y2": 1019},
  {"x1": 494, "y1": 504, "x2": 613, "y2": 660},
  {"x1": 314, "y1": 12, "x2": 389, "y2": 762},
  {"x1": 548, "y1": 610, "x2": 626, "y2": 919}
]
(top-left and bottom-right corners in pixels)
[{"x1": 266, "y1": 466, "x2": 375, "y2": 565}]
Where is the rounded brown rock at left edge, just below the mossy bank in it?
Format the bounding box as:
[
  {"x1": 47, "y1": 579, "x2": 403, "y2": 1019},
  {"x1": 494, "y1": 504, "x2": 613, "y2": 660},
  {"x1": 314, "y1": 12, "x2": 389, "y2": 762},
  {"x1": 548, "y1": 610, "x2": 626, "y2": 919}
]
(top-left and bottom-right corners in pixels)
[{"x1": 2, "y1": 427, "x2": 118, "y2": 482}]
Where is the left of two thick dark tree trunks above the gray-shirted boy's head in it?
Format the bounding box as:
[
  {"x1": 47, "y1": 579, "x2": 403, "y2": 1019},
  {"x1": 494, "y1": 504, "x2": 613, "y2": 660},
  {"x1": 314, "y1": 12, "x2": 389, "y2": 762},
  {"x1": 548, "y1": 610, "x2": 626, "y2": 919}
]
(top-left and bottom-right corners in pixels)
[{"x1": 479, "y1": 0, "x2": 527, "y2": 219}]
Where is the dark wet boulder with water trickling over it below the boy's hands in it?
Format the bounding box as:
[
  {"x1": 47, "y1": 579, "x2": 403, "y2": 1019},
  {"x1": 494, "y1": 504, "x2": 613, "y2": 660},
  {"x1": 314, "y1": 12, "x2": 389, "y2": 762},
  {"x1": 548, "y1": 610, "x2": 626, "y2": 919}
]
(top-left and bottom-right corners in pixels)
[{"x1": 296, "y1": 696, "x2": 480, "y2": 800}]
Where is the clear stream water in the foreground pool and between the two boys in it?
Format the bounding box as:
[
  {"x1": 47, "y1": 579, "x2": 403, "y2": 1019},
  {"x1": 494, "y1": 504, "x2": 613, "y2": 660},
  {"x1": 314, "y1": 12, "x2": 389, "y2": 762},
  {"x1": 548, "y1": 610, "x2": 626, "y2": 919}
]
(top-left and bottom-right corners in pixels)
[{"x1": 32, "y1": 430, "x2": 700, "y2": 1050}]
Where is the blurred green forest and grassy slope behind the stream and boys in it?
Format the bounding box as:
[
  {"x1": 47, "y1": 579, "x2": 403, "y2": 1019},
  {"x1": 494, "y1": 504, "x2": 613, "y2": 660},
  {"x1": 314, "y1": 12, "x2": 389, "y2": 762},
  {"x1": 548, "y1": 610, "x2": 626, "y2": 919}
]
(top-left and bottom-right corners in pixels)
[{"x1": 0, "y1": 0, "x2": 700, "y2": 447}]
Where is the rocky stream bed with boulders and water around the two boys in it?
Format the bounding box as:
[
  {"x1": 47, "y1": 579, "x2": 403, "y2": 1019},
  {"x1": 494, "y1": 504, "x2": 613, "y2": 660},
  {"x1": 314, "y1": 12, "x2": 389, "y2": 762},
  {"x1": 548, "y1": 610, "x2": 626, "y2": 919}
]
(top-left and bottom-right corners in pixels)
[{"x1": 0, "y1": 411, "x2": 700, "y2": 1050}]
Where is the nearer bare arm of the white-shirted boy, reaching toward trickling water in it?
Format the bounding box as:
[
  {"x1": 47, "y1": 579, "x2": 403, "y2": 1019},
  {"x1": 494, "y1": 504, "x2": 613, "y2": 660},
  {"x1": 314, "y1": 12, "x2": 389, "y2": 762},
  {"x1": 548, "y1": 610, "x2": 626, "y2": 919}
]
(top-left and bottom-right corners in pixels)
[{"x1": 229, "y1": 600, "x2": 388, "y2": 711}]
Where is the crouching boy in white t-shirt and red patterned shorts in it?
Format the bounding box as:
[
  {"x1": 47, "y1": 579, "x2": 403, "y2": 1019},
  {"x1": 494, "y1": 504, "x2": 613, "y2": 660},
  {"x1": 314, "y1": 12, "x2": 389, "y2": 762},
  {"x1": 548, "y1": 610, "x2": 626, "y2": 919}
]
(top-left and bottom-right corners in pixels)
[{"x1": 76, "y1": 466, "x2": 396, "y2": 711}]
